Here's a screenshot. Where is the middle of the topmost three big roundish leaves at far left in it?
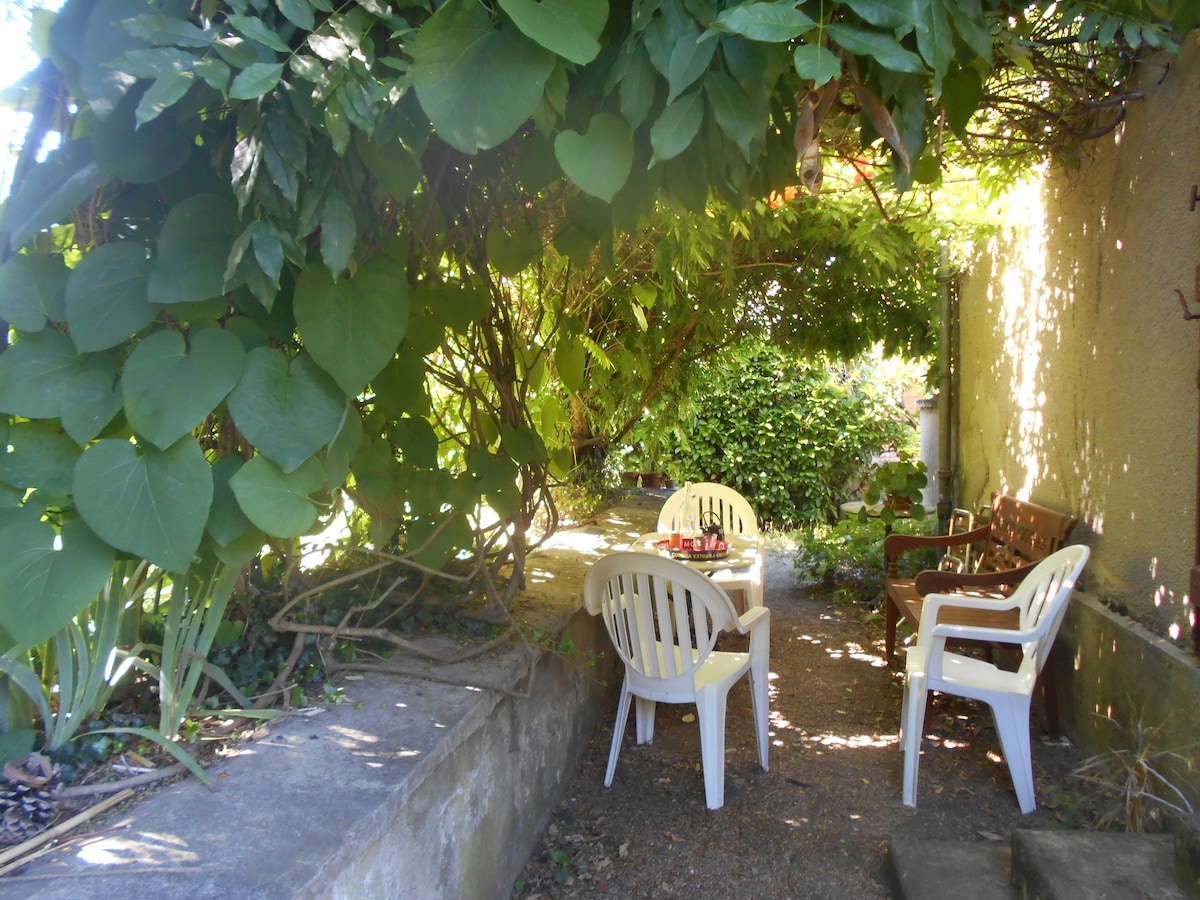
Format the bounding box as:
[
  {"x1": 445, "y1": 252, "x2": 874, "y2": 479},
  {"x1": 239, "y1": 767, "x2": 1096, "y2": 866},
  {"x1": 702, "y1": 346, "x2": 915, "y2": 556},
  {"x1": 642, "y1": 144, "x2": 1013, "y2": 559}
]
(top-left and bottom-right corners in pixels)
[{"x1": 66, "y1": 241, "x2": 162, "y2": 353}]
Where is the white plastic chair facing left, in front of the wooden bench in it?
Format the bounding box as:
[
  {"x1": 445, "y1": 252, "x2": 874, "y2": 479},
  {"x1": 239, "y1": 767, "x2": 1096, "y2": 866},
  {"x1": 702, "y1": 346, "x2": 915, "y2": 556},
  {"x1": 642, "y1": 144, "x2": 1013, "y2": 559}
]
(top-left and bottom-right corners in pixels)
[{"x1": 900, "y1": 546, "x2": 1091, "y2": 815}]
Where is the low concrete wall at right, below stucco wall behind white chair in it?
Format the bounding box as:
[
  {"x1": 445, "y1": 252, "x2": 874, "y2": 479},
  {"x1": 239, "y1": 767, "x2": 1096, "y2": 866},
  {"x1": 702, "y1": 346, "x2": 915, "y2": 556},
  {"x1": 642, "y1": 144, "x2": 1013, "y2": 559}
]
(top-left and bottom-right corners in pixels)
[{"x1": 1055, "y1": 593, "x2": 1200, "y2": 800}]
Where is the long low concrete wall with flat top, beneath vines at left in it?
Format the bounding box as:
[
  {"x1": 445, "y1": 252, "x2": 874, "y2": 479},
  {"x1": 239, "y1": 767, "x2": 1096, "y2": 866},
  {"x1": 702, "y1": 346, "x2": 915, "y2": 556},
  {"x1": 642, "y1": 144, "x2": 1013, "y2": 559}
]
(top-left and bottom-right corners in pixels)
[{"x1": 0, "y1": 498, "x2": 661, "y2": 900}]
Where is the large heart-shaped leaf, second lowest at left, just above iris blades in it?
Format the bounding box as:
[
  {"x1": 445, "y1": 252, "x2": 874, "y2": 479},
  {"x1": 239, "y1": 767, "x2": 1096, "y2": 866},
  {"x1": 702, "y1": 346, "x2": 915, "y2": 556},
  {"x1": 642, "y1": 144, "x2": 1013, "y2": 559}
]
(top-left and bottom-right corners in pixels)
[{"x1": 73, "y1": 438, "x2": 212, "y2": 572}]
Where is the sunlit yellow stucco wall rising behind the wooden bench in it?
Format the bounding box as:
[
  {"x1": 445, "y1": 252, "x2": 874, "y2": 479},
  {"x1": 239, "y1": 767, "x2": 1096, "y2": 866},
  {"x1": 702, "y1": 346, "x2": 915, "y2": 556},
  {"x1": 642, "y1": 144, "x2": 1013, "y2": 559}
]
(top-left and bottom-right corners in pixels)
[{"x1": 955, "y1": 32, "x2": 1200, "y2": 640}]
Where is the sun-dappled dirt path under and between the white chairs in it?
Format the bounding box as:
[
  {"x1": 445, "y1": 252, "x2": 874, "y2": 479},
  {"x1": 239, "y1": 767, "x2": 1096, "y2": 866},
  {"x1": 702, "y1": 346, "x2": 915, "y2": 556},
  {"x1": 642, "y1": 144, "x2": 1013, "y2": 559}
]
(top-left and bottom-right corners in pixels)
[{"x1": 514, "y1": 553, "x2": 1096, "y2": 899}]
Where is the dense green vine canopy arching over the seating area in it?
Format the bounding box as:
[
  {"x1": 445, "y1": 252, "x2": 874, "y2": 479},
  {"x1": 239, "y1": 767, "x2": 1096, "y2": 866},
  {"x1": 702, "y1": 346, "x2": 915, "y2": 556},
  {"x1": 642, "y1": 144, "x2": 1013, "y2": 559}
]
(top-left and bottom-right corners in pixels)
[{"x1": 0, "y1": 0, "x2": 1196, "y2": 647}]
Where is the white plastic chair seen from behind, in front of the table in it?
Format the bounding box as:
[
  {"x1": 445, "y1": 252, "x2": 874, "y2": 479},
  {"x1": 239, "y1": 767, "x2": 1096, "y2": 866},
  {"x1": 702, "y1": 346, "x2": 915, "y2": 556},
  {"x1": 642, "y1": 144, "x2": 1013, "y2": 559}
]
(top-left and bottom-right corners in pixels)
[{"x1": 583, "y1": 553, "x2": 770, "y2": 809}]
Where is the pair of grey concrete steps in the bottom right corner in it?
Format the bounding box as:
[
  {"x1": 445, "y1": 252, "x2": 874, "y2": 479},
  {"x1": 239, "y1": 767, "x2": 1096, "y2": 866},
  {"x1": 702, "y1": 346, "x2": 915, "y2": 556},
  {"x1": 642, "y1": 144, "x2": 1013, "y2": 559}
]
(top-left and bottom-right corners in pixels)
[{"x1": 888, "y1": 830, "x2": 1190, "y2": 900}]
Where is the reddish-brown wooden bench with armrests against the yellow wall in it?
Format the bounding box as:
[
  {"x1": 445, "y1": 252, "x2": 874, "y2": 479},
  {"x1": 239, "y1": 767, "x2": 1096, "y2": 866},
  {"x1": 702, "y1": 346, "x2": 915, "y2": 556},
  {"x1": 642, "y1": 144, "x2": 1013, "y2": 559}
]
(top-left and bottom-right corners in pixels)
[{"x1": 883, "y1": 493, "x2": 1075, "y2": 736}]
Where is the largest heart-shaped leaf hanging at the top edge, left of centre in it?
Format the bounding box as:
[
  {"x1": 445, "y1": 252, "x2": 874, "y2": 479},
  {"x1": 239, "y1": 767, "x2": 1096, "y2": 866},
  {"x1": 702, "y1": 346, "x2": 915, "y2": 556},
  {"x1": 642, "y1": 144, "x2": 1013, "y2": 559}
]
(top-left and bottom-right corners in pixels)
[{"x1": 412, "y1": 0, "x2": 556, "y2": 154}]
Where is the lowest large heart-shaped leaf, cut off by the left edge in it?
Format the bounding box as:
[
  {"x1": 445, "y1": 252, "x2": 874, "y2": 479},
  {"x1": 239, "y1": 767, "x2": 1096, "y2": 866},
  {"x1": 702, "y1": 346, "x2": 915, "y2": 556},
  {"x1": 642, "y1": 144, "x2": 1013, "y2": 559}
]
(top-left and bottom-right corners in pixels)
[{"x1": 0, "y1": 509, "x2": 115, "y2": 647}]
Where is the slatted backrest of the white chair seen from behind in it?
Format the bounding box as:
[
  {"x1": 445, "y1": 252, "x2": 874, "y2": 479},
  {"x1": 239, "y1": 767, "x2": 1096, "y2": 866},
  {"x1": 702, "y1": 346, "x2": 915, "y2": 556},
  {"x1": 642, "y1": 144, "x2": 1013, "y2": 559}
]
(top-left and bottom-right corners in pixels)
[{"x1": 583, "y1": 553, "x2": 737, "y2": 689}]
